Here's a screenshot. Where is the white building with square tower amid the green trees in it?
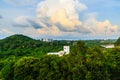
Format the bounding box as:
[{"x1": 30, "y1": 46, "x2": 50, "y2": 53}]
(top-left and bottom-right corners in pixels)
[{"x1": 48, "y1": 46, "x2": 70, "y2": 56}]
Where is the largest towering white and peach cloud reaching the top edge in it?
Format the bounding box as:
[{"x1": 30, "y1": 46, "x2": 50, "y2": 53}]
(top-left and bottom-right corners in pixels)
[{"x1": 37, "y1": 0, "x2": 88, "y2": 32}]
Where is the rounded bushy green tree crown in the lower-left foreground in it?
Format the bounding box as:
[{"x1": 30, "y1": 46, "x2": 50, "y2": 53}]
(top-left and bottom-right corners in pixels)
[{"x1": 14, "y1": 57, "x2": 39, "y2": 80}]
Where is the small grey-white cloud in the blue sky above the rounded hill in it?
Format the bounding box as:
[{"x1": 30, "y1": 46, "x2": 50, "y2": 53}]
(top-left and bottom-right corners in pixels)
[{"x1": 13, "y1": 16, "x2": 42, "y2": 29}]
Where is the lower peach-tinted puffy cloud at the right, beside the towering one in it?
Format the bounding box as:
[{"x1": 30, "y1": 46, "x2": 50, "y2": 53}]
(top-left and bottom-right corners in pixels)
[{"x1": 84, "y1": 16, "x2": 119, "y2": 35}]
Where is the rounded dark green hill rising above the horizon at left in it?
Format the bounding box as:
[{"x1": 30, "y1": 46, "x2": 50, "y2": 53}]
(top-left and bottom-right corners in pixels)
[{"x1": 0, "y1": 34, "x2": 36, "y2": 50}]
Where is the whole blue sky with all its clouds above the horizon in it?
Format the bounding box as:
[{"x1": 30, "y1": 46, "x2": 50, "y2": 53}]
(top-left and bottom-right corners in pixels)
[{"x1": 0, "y1": 0, "x2": 120, "y2": 40}]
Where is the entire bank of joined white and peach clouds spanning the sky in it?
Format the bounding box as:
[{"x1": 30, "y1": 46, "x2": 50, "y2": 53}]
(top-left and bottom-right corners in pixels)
[{"x1": 7, "y1": 0, "x2": 119, "y2": 38}]
